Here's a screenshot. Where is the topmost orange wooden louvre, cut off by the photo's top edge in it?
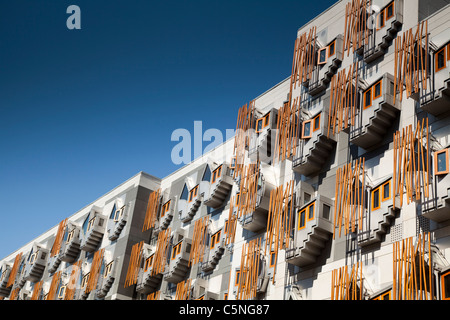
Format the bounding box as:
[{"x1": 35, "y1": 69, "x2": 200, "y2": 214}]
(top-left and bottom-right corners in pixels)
[{"x1": 342, "y1": 0, "x2": 372, "y2": 59}]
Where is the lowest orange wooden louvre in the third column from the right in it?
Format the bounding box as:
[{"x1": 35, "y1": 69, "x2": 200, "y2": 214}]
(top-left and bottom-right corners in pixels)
[{"x1": 264, "y1": 180, "x2": 294, "y2": 282}]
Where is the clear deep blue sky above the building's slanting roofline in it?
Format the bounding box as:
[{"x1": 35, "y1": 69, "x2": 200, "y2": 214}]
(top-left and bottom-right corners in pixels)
[{"x1": 0, "y1": 0, "x2": 336, "y2": 259}]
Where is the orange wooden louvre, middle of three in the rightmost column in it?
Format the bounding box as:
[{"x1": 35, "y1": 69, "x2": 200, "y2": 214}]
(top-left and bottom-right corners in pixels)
[{"x1": 393, "y1": 118, "x2": 430, "y2": 208}]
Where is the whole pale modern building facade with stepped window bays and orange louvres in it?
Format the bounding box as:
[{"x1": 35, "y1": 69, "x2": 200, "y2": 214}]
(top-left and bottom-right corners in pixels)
[{"x1": 0, "y1": 0, "x2": 450, "y2": 300}]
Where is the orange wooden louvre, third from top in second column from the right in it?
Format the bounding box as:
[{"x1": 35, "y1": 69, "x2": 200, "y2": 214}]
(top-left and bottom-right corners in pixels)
[{"x1": 333, "y1": 158, "x2": 365, "y2": 239}]
